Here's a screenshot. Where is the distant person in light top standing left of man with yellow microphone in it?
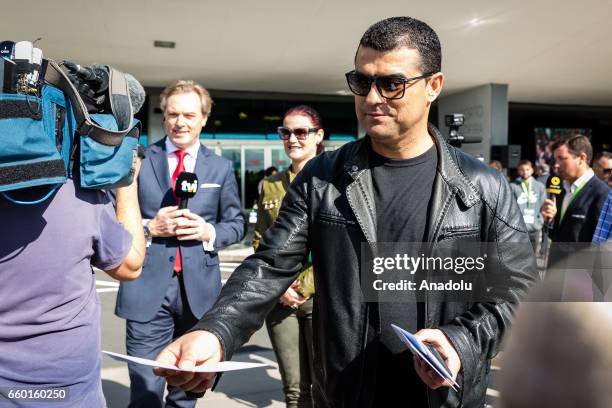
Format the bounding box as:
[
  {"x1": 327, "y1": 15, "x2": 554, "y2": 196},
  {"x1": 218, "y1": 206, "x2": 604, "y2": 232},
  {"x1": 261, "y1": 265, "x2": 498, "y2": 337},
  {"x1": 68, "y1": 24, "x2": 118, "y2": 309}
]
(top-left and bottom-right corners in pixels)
[{"x1": 511, "y1": 160, "x2": 546, "y2": 253}]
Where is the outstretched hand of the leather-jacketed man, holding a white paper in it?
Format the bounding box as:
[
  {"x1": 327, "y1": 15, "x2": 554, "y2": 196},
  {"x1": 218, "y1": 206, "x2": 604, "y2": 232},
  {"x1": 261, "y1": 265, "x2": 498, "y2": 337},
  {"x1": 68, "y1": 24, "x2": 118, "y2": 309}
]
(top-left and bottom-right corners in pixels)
[{"x1": 153, "y1": 330, "x2": 223, "y2": 393}]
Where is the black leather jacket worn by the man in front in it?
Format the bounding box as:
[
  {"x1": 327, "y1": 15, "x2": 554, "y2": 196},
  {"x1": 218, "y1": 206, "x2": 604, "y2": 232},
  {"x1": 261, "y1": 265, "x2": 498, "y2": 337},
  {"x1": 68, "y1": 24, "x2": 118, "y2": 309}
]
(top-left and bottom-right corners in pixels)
[{"x1": 194, "y1": 125, "x2": 536, "y2": 408}]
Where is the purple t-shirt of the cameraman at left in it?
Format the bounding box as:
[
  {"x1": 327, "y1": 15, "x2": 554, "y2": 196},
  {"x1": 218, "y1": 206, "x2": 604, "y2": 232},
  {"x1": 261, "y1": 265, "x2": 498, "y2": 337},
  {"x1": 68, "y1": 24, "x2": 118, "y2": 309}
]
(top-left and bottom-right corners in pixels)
[{"x1": 0, "y1": 180, "x2": 132, "y2": 408}]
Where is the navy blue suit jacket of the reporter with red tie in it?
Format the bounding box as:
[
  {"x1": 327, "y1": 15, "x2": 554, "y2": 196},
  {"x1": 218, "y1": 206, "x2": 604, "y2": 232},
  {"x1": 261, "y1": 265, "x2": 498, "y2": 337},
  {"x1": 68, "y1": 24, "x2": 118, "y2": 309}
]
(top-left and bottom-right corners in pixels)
[{"x1": 115, "y1": 139, "x2": 244, "y2": 322}]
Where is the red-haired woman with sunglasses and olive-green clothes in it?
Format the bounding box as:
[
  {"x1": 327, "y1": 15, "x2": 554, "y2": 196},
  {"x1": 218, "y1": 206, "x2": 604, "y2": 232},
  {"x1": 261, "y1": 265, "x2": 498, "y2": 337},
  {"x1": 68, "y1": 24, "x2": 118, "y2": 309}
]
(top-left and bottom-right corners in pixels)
[{"x1": 253, "y1": 105, "x2": 324, "y2": 408}]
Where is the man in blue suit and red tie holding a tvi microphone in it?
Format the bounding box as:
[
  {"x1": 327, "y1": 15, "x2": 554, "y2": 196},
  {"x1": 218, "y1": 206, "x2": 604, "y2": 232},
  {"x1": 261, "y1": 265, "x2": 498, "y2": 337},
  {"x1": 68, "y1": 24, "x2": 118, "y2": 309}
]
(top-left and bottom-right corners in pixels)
[{"x1": 115, "y1": 81, "x2": 244, "y2": 408}]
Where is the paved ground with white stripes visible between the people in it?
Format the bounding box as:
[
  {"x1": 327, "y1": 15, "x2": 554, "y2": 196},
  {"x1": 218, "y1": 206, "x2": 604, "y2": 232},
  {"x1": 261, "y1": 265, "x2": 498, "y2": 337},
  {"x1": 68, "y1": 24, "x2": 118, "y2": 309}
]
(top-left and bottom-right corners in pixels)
[{"x1": 97, "y1": 244, "x2": 498, "y2": 408}]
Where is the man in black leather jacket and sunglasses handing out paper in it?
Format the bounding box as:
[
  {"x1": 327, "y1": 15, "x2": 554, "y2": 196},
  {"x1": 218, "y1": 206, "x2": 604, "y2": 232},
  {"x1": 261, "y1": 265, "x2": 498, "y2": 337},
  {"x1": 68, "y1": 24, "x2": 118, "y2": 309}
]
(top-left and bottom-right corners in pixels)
[{"x1": 156, "y1": 17, "x2": 536, "y2": 408}]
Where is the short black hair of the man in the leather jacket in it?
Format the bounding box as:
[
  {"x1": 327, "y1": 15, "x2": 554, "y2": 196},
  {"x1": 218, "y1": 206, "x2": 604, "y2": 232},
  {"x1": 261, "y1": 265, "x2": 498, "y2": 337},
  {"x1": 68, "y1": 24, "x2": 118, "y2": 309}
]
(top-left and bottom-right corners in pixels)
[{"x1": 359, "y1": 17, "x2": 442, "y2": 74}]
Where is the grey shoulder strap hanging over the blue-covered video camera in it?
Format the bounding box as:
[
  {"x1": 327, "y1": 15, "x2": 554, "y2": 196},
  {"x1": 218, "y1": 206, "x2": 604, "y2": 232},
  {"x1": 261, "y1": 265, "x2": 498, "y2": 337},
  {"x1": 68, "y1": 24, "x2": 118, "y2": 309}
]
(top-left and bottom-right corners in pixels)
[{"x1": 44, "y1": 60, "x2": 138, "y2": 146}]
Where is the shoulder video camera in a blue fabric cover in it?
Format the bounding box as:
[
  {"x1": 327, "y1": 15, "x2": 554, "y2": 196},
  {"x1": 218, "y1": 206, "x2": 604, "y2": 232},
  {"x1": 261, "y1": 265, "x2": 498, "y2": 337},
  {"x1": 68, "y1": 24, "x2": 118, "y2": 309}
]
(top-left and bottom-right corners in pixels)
[{"x1": 0, "y1": 41, "x2": 144, "y2": 204}]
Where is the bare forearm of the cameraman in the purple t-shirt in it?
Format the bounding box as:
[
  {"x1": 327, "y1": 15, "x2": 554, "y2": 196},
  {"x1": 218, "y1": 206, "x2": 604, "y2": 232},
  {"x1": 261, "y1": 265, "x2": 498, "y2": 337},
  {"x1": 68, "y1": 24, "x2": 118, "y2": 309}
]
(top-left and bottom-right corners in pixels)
[{"x1": 105, "y1": 159, "x2": 145, "y2": 280}]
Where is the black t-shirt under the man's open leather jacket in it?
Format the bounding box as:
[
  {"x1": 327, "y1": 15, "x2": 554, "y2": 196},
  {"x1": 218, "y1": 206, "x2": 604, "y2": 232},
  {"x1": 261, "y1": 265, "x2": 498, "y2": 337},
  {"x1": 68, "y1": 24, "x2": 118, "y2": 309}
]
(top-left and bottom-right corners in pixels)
[{"x1": 370, "y1": 142, "x2": 438, "y2": 406}]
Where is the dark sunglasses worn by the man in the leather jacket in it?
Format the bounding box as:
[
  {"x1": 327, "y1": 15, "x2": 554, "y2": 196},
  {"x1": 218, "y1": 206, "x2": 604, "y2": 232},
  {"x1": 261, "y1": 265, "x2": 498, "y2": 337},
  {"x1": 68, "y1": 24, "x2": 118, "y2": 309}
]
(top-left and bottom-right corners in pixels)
[{"x1": 345, "y1": 71, "x2": 434, "y2": 99}]
